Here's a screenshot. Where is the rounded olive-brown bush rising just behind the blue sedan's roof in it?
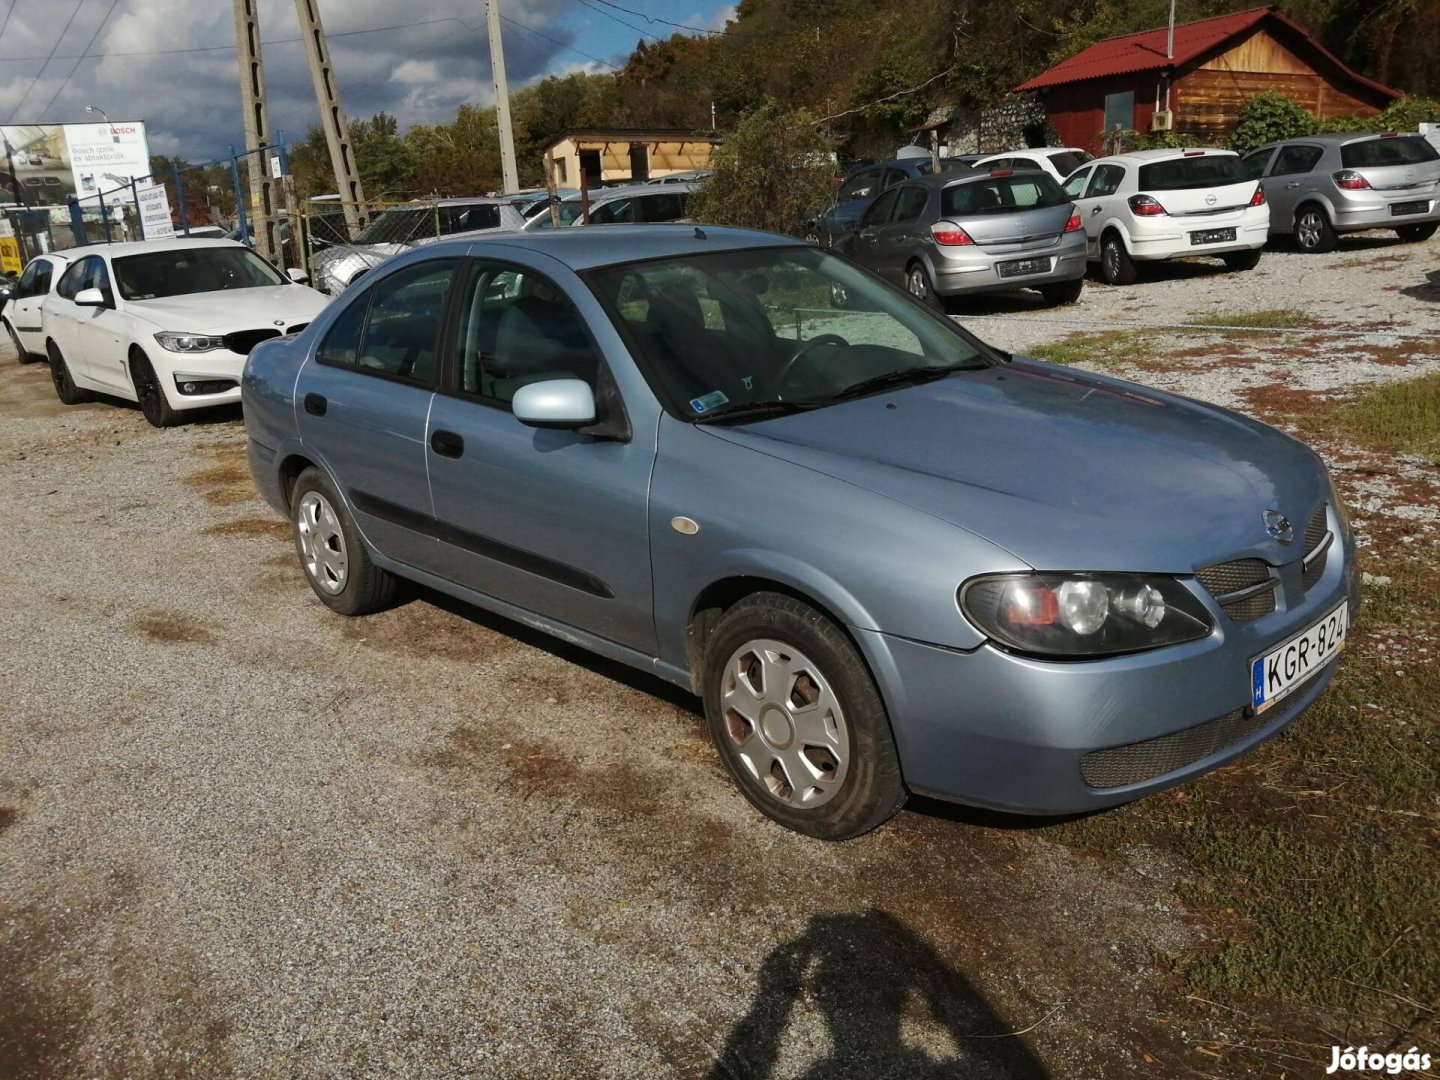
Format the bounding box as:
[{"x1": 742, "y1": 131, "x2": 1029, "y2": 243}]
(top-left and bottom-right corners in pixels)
[{"x1": 690, "y1": 101, "x2": 835, "y2": 236}]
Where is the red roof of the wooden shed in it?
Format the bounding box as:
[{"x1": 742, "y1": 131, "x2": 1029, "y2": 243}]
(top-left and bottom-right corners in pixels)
[{"x1": 1015, "y1": 7, "x2": 1400, "y2": 98}]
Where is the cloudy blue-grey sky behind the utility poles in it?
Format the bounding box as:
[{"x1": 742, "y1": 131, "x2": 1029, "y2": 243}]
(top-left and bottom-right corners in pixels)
[{"x1": 0, "y1": 0, "x2": 734, "y2": 161}]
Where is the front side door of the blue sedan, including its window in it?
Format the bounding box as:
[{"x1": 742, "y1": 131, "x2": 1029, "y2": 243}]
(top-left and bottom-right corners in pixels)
[{"x1": 428, "y1": 261, "x2": 655, "y2": 655}]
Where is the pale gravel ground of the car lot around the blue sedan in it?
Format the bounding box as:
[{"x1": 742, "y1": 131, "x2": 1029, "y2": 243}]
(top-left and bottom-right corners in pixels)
[{"x1": 0, "y1": 230, "x2": 1440, "y2": 1080}]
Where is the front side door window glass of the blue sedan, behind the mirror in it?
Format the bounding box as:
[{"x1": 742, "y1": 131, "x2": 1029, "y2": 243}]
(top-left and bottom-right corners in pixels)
[{"x1": 458, "y1": 264, "x2": 600, "y2": 405}]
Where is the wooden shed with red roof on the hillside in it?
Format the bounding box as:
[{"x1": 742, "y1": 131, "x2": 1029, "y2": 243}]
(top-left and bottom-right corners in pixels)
[{"x1": 1015, "y1": 7, "x2": 1400, "y2": 151}]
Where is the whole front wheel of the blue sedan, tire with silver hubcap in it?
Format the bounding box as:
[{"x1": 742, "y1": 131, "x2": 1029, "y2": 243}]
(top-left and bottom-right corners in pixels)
[{"x1": 701, "y1": 592, "x2": 906, "y2": 840}]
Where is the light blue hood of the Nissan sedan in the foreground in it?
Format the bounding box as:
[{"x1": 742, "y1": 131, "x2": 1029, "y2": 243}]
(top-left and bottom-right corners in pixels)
[{"x1": 706, "y1": 360, "x2": 1326, "y2": 573}]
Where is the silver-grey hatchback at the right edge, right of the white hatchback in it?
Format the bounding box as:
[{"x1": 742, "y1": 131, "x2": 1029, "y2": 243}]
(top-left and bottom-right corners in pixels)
[{"x1": 1243, "y1": 134, "x2": 1440, "y2": 252}]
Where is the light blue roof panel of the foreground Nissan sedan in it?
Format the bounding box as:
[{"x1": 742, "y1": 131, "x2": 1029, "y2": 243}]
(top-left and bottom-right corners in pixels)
[{"x1": 460, "y1": 225, "x2": 808, "y2": 271}]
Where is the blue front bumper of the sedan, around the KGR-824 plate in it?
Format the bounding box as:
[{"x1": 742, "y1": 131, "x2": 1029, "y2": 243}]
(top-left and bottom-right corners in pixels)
[{"x1": 852, "y1": 529, "x2": 1358, "y2": 815}]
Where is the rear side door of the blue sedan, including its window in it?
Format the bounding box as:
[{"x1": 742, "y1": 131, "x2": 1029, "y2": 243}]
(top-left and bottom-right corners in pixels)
[{"x1": 295, "y1": 259, "x2": 449, "y2": 570}]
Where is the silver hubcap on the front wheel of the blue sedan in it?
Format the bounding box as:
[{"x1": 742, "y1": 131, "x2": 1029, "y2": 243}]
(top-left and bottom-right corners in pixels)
[{"x1": 720, "y1": 639, "x2": 850, "y2": 809}]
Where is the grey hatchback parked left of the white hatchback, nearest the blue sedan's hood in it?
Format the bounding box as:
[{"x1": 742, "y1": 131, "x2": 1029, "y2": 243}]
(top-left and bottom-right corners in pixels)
[{"x1": 837, "y1": 170, "x2": 1086, "y2": 307}]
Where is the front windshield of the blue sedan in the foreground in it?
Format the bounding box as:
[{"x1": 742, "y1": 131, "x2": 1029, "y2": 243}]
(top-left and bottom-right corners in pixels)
[{"x1": 586, "y1": 246, "x2": 991, "y2": 422}]
